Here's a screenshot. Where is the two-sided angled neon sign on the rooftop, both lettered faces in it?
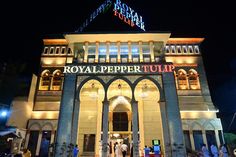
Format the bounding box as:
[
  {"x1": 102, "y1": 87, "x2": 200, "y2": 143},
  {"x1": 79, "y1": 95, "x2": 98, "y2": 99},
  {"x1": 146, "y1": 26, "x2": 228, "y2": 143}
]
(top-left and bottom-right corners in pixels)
[{"x1": 75, "y1": 0, "x2": 145, "y2": 32}]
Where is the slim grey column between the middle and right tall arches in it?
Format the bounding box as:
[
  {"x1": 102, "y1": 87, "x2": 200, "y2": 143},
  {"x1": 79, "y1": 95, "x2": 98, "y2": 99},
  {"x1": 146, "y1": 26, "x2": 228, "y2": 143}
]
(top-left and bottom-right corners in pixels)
[{"x1": 131, "y1": 100, "x2": 139, "y2": 157}]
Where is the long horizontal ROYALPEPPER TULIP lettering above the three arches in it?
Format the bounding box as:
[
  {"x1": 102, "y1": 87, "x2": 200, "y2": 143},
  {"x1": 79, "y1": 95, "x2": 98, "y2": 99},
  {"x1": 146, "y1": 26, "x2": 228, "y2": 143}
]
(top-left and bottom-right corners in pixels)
[{"x1": 63, "y1": 64, "x2": 174, "y2": 74}]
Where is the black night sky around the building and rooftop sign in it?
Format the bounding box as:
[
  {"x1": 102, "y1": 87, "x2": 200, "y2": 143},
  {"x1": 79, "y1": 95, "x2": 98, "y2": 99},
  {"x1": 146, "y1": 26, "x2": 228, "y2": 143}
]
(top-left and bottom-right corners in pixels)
[{"x1": 0, "y1": 0, "x2": 236, "y2": 131}]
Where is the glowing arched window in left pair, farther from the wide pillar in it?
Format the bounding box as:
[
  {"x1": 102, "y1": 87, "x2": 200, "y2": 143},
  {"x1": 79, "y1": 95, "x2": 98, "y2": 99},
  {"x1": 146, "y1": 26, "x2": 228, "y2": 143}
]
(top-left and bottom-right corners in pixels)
[{"x1": 39, "y1": 70, "x2": 50, "y2": 90}]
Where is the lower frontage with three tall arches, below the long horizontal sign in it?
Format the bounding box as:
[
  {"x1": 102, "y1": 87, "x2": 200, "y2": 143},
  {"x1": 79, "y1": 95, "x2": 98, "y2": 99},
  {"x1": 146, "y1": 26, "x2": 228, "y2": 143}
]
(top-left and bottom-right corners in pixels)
[{"x1": 23, "y1": 73, "x2": 223, "y2": 156}]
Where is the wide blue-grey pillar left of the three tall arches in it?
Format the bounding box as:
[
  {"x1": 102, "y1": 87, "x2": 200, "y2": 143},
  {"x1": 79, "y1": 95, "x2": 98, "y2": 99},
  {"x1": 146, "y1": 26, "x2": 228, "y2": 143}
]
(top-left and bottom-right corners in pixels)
[{"x1": 55, "y1": 74, "x2": 77, "y2": 157}]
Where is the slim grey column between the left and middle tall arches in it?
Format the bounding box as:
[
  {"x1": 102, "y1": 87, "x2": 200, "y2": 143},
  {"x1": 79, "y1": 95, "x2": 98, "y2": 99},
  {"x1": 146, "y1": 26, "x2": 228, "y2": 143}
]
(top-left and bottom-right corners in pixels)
[{"x1": 102, "y1": 100, "x2": 109, "y2": 157}]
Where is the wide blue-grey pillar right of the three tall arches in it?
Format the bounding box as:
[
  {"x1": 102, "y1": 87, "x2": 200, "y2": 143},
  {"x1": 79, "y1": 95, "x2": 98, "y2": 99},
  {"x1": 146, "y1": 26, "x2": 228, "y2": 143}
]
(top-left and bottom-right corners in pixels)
[{"x1": 162, "y1": 72, "x2": 186, "y2": 157}]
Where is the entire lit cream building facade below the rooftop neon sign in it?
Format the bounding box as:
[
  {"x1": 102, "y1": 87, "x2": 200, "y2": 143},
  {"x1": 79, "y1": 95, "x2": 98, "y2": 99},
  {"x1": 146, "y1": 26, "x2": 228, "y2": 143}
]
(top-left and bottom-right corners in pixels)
[{"x1": 8, "y1": 33, "x2": 224, "y2": 156}]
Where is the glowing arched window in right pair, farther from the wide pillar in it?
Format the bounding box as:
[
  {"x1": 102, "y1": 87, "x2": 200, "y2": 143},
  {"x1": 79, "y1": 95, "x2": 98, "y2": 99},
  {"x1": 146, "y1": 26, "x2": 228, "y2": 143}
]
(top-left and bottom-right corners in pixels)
[{"x1": 188, "y1": 69, "x2": 200, "y2": 89}]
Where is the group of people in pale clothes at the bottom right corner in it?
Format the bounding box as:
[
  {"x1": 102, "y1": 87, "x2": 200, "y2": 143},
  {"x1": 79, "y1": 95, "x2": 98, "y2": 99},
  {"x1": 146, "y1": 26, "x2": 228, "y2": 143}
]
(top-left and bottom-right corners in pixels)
[{"x1": 200, "y1": 144, "x2": 229, "y2": 157}]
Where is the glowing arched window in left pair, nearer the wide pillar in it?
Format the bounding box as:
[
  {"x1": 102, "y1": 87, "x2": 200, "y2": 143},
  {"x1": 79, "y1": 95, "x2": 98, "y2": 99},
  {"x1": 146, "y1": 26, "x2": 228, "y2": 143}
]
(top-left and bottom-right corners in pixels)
[{"x1": 51, "y1": 70, "x2": 63, "y2": 90}]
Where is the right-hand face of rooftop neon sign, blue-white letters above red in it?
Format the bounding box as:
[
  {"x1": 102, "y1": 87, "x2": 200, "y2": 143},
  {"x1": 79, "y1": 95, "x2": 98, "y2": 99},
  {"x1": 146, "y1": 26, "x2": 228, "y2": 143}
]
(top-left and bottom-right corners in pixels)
[{"x1": 113, "y1": 0, "x2": 145, "y2": 31}]
